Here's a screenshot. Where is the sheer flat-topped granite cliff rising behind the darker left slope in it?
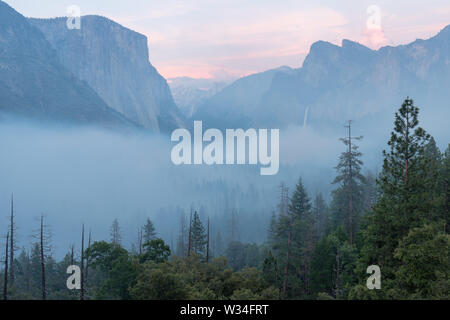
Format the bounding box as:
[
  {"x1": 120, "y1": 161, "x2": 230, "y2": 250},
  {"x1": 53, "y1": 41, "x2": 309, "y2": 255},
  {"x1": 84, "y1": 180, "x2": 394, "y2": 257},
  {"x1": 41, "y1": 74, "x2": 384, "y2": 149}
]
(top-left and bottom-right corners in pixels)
[{"x1": 29, "y1": 16, "x2": 183, "y2": 132}]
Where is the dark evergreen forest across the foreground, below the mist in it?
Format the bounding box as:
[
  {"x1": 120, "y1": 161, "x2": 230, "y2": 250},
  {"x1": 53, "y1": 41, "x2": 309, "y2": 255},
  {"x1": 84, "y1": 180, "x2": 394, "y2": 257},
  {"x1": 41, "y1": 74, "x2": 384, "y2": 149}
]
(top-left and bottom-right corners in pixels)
[{"x1": 0, "y1": 98, "x2": 450, "y2": 299}]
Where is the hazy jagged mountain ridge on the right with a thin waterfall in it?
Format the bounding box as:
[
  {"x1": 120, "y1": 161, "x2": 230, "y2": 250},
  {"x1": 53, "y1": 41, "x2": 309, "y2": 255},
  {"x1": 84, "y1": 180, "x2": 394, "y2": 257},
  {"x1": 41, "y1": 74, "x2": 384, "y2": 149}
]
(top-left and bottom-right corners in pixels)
[{"x1": 194, "y1": 26, "x2": 450, "y2": 128}]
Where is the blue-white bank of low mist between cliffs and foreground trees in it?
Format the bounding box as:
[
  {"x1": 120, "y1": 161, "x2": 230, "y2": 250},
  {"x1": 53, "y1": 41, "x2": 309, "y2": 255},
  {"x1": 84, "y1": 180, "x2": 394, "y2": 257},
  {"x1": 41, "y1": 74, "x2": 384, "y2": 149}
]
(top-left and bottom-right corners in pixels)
[{"x1": 0, "y1": 114, "x2": 446, "y2": 257}]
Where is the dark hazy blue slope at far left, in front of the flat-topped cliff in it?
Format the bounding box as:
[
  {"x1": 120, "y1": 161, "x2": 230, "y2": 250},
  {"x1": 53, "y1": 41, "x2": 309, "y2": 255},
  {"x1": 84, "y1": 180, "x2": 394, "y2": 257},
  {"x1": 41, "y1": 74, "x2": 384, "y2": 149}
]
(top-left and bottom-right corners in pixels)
[{"x1": 0, "y1": 1, "x2": 137, "y2": 128}]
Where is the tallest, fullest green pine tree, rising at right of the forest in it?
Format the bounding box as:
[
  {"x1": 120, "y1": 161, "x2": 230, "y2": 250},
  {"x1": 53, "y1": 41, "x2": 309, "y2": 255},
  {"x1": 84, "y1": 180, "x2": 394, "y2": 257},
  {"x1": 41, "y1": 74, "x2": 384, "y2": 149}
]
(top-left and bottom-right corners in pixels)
[{"x1": 359, "y1": 98, "x2": 434, "y2": 292}]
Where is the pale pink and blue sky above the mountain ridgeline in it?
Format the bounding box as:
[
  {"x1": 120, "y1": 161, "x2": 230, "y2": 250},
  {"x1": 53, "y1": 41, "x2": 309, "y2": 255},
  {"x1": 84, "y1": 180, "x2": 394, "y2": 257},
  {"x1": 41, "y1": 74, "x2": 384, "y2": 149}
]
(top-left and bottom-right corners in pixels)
[{"x1": 6, "y1": 0, "x2": 450, "y2": 80}]
